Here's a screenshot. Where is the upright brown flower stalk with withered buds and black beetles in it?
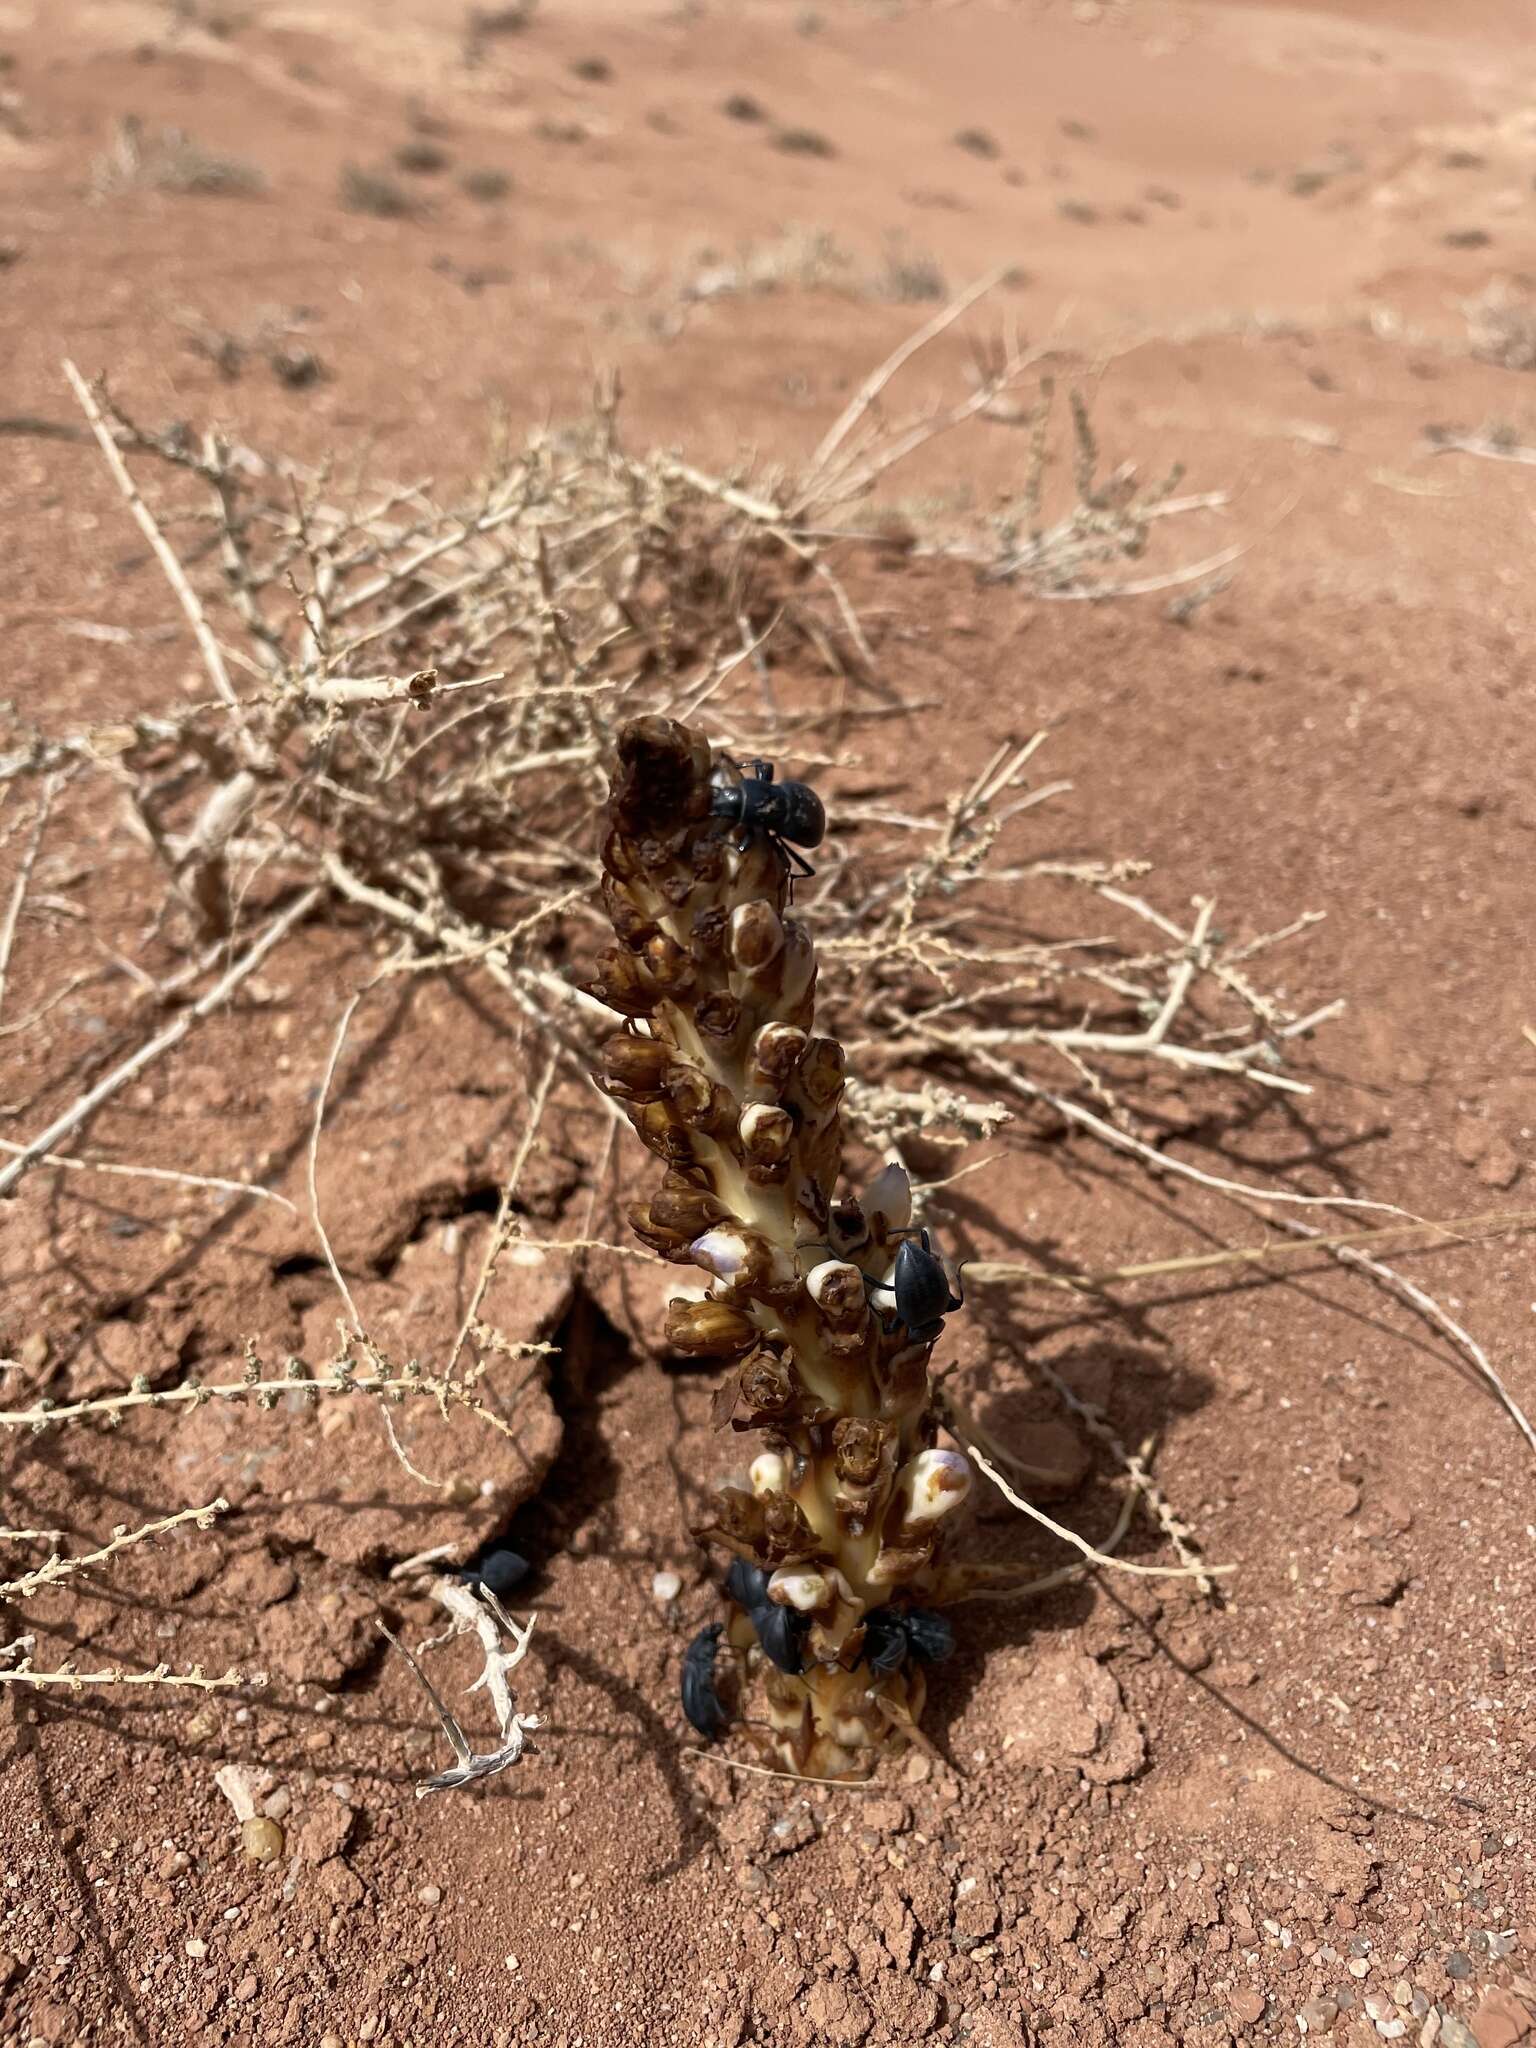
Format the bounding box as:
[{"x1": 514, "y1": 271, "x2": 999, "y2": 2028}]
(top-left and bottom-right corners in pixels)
[{"x1": 592, "y1": 719, "x2": 971, "y2": 1778}]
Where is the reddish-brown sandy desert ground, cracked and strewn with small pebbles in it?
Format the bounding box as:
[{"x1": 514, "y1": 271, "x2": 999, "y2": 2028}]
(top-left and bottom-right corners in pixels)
[{"x1": 0, "y1": 0, "x2": 1536, "y2": 2048}]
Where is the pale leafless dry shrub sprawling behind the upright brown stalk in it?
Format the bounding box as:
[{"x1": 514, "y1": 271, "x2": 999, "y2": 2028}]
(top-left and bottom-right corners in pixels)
[{"x1": 0, "y1": 289, "x2": 1515, "y2": 1728}]
